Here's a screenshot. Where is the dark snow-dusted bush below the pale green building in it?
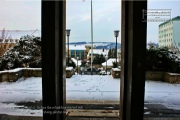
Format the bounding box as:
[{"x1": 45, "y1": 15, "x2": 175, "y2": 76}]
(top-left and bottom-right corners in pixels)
[{"x1": 146, "y1": 47, "x2": 180, "y2": 73}]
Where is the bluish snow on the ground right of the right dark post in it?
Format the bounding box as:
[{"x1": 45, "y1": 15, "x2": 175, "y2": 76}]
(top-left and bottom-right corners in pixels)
[{"x1": 145, "y1": 80, "x2": 180, "y2": 110}]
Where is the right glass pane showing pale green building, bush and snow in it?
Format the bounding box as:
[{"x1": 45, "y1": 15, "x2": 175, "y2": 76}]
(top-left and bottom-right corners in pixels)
[{"x1": 144, "y1": 0, "x2": 180, "y2": 118}]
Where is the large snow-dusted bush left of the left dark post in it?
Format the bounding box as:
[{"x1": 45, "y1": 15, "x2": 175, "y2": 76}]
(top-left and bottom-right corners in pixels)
[{"x1": 0, "y1": 35, "x2": 41, "y2": 70}]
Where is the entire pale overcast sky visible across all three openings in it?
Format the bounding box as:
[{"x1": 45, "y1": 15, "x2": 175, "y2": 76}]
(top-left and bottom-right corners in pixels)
[{"x1": 0, "y1": 0, "x2": 180, "y2": 43}]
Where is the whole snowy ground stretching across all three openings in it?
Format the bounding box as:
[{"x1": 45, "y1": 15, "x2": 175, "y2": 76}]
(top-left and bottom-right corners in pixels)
[{"x1": 0, "y1": 75, "x2": 180, "y2": 116}]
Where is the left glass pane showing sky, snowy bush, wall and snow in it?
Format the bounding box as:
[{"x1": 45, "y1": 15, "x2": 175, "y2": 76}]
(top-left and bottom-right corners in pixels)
[{"x1": 0, "y1": 0, "x2": 43, "y2": 120}]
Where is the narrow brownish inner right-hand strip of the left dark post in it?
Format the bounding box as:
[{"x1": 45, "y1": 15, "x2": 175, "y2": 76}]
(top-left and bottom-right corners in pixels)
[{"x1": 55, "y1": 1, "x2": 66, "y2": 120}]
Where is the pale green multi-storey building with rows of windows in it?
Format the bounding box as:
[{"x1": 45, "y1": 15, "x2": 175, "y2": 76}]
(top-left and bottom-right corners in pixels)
[{"x1": 158, "y1": 16, "x2": 180, "y2": 48}]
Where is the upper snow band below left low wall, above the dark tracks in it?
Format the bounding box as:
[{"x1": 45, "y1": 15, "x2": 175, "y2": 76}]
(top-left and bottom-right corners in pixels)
[{"x1": 0, "y1": 77, "x2": 42, "y2": 102}]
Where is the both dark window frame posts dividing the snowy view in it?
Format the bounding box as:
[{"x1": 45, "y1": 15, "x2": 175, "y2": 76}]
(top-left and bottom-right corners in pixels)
[{"x1": 42, "y1": 0, "x2": 147, "y2": 120}]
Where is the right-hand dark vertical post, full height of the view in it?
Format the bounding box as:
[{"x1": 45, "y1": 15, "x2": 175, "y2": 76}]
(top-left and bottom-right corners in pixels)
[{"x1": 120, "y1": 0, "x2": 147, "y2": 120}]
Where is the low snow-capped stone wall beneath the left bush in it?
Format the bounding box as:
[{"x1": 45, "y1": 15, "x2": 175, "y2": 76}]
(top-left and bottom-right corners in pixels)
[{"x1": 0, "y1": 68, "x2": 42, "y2": 82}]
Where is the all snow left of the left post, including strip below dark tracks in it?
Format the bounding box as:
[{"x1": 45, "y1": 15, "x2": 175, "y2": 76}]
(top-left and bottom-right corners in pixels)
[{"x1": 0, "y1": 77, "x2": 42, "y2": 116}]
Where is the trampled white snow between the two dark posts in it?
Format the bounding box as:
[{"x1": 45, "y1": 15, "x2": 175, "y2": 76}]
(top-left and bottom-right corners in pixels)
[{"x1": 66, "y1": 75, "x2": 120, "y2": 100}]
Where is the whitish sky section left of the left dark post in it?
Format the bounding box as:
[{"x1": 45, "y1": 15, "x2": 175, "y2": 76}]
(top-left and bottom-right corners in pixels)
[{"x1": 0, "y1": 0, "x2": 41, "y2": 30}]
